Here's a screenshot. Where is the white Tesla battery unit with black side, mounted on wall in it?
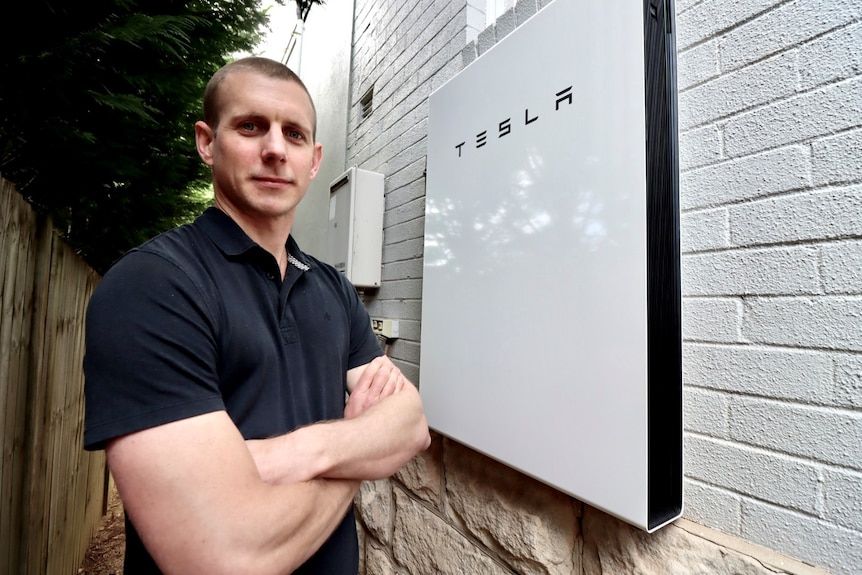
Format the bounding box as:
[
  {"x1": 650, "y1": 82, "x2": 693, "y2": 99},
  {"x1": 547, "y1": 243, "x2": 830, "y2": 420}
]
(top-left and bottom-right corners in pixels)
[{"x1": 420, "y1": 0, "x2": 682, "y2": 531}]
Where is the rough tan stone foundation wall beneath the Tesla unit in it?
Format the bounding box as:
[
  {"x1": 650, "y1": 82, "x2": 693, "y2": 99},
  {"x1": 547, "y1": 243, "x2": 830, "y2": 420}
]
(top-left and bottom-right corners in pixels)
[{"x1": 356, "y1": 434, "x2": 827, "y2": 575}]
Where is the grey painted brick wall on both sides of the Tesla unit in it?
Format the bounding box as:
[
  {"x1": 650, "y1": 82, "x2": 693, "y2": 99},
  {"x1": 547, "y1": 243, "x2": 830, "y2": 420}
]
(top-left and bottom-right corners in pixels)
[{"x1": 348, "y1": 0, "x2": 862, "y2": 575}]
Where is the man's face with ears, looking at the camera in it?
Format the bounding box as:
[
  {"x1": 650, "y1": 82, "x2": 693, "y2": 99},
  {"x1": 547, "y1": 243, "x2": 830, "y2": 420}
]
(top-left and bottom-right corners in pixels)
[{"x1": 195, "y1": 71, "x2": 321, "y2": 226}]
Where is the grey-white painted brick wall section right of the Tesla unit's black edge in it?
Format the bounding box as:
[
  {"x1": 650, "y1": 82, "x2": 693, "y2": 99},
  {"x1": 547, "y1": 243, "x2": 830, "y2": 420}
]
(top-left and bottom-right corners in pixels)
[{"x1": 677, "y1": 0, "x2": 862, "y2": 574}]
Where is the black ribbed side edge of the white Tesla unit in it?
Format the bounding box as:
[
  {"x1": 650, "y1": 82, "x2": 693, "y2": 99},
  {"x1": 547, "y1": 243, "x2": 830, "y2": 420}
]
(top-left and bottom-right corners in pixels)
[{"x1": 644, "y1": 0, "x2": 683, "y2": 531}]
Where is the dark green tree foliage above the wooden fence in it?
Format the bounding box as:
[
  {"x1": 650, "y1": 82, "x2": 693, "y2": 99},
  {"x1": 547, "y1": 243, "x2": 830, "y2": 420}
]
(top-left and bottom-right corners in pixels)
[{"x1": 0, "y1": 0, "x2": 280, "y2": 272}]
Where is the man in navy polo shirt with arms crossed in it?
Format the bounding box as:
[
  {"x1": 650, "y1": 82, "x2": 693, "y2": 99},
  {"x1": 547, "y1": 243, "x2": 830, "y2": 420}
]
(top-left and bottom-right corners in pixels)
[{"x1": 84, "y1": 58, "x2": 430, "y2": 575}]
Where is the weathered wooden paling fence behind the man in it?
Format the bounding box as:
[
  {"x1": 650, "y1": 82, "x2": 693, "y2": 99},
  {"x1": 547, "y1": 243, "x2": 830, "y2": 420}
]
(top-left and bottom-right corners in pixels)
[{"x1": 0, "y1": 178, "x2": 108, "y2": 575}]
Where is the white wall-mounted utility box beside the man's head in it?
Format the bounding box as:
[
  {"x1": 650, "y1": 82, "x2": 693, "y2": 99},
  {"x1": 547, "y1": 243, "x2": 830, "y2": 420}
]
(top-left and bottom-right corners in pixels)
[{"x1": 326, "y1": 166, "x2": 384, "y2": 288}]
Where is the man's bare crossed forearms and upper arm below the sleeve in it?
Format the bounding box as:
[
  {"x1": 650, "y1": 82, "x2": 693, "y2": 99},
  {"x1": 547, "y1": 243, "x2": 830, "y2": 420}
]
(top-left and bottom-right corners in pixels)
[{"x1": 106, "y1": 357, "x2": 430, "y2": 574}]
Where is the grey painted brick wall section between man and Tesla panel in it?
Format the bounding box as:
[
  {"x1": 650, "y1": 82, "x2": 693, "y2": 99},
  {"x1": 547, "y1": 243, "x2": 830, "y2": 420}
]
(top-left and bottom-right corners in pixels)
[{"x1": 347, "y1": 0, "x2": 470, "y2": 388}]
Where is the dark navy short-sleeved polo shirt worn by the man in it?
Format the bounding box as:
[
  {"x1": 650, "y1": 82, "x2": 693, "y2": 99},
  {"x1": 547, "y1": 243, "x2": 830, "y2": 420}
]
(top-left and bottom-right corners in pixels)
[{"x1": 84, "y1": 208, "x2": 381, "y2": 575}]
